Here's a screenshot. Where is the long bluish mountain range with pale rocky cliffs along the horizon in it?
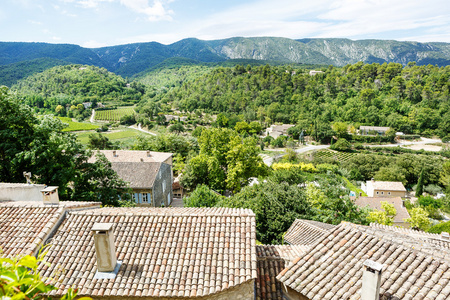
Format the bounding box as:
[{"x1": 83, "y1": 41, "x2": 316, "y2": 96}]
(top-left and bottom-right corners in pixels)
[{"x1": 0, "y1": 37, "x2": 450, "y2": 84}]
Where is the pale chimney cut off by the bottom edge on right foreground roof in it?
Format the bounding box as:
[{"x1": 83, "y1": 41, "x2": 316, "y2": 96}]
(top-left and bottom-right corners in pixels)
[{"x1": 361, "y1": 259, "x2": 383, "y2": 300}]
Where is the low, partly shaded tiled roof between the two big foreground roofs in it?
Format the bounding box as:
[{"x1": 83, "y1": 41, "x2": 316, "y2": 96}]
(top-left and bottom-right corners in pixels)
[{"x1": 255, "y1": 245, "x2": 309, "y2": 300}]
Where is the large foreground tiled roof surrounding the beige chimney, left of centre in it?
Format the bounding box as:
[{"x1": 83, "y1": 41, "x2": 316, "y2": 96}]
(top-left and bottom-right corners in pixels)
[{"x1": 41, "y1": 208, "x2": 256, "y2": 297}]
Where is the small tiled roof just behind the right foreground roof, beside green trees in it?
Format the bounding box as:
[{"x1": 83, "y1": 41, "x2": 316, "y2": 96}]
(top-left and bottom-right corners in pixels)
[{"x1": 284, "y1": 219, "x2": 335, "y2": 245}]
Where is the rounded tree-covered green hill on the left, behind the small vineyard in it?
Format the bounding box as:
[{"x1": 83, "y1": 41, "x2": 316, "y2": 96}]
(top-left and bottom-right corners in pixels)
[{"x1": 11, "y1": 65, "x2": 144, "y2": 112}]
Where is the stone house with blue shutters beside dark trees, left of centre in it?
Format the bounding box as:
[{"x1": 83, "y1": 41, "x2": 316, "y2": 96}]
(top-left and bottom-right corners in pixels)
[{"x1": 88, "y1": 150, "x2": 173, "y2": 207}]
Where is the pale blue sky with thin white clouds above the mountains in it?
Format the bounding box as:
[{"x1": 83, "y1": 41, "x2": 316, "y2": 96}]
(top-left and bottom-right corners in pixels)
[{"x1": 0, "y1": 0, "x2": 450, "y2": 48}]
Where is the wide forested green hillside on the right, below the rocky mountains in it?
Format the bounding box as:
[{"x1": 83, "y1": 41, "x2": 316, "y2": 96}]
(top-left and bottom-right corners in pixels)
[{"x1": 143, "y1": 62, "x2": 450, "y2": 140}]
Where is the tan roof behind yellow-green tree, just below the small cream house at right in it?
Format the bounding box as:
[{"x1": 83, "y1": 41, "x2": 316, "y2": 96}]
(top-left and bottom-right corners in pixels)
[{"x1": 354, "y1": 197, "x2": 410, "y2": 227}]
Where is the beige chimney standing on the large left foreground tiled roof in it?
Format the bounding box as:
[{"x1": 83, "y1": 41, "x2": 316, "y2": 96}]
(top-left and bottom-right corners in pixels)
[{"x1": 91, "y1": 223, "x2": 117, "y2": 272}]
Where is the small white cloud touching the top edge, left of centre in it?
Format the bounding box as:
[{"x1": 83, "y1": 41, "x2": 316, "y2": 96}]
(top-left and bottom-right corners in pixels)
[{"x1": 120, "y1": 0, "x2": 173, "y2": 21}]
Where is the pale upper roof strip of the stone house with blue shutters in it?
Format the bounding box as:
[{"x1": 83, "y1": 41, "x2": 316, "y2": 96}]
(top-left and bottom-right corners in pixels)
[{"x1": 88, "y1": 150, "x2": 173, "y2": 163}]
